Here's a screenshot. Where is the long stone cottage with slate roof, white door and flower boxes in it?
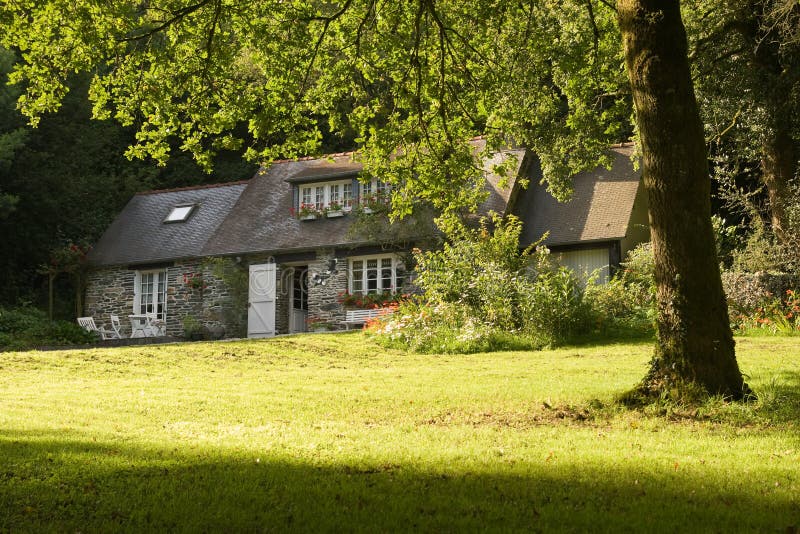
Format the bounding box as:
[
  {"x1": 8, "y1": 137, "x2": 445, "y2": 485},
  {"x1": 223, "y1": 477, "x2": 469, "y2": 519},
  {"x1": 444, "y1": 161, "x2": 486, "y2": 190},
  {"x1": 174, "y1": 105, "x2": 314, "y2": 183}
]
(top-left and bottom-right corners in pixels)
[{"x1": 85, "y1": 141, "x2": 648, "y2": 337}]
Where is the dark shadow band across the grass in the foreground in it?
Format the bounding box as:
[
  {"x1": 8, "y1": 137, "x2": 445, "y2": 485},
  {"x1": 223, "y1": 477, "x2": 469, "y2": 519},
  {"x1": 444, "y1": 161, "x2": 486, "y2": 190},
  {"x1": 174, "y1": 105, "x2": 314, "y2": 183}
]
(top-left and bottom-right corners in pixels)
[{"x1": 0, "y1": 432, "x2": 800, "y2": 532}]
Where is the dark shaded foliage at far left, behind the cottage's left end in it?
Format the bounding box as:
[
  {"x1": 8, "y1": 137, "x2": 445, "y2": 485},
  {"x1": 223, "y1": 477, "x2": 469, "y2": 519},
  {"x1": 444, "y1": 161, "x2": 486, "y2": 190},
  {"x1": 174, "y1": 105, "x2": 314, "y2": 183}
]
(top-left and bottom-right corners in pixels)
[{"x1": 0, "y1": 48, "x2": 255, "y2": 318}]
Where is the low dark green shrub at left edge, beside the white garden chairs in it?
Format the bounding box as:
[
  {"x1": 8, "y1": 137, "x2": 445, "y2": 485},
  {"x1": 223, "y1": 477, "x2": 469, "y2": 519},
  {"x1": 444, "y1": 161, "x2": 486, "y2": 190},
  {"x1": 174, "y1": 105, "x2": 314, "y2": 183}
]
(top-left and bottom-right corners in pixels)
[{"x1": 0, "y1": 307, "x2": 97, "y2": 350}]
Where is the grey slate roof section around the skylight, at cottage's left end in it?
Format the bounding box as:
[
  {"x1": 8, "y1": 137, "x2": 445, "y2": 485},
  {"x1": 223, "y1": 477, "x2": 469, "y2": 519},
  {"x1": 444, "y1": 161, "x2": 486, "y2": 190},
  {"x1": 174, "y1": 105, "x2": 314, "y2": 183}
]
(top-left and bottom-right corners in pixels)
[{"x1": 89, "y1": 182, "x2": 247, "y2": 266}]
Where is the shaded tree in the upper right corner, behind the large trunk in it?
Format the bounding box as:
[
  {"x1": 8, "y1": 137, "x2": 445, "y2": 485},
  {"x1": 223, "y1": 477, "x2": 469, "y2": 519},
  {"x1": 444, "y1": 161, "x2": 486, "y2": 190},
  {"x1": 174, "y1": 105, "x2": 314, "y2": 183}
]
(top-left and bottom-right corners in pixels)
[{"x1": 685, "y1": 0, "x2": 800, "y2": 243}]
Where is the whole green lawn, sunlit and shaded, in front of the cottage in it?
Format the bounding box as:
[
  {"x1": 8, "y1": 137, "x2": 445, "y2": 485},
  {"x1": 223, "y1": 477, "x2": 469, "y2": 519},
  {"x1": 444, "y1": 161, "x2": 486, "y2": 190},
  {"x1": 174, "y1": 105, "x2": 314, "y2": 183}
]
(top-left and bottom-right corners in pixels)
[{"x1": 0, "y1": 333, "x2": 800, "y2": 532}]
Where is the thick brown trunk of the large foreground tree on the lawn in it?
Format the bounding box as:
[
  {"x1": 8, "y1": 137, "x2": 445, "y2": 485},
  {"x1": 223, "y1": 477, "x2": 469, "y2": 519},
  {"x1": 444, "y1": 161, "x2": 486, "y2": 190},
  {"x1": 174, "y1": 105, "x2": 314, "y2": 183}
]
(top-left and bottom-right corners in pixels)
[{"x1": 617, "y1": 0, "x2": 748, "y2": 399}]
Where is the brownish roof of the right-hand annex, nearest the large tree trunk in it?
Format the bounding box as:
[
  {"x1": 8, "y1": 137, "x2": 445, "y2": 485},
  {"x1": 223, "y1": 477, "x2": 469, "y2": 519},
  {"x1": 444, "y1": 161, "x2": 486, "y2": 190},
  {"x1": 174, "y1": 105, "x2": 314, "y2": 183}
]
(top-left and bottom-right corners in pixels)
[{"x1": 513, "y1": 146, "x2": 641, "y2": 246}]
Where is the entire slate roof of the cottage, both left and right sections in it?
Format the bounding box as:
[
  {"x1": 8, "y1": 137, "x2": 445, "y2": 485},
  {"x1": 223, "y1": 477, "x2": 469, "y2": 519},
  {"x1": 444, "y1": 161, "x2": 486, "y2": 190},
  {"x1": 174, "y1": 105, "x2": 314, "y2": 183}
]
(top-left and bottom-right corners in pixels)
[{"x1": 89, "y1": 143, "x2": 639, "y2": 266}]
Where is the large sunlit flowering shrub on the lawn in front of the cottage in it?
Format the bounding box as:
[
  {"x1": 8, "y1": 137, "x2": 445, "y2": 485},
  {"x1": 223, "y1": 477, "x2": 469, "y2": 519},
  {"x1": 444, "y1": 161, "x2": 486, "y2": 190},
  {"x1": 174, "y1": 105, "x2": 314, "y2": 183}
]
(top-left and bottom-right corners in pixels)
[{"x1": 372, "y1": 217, "x2": 591, "y2": 353}]
